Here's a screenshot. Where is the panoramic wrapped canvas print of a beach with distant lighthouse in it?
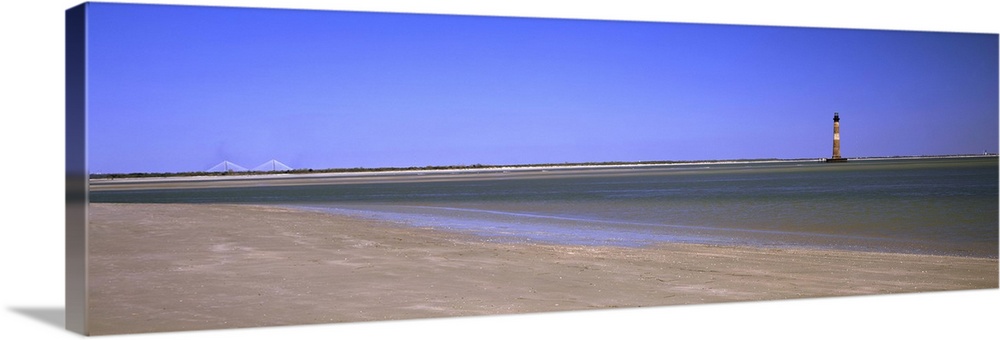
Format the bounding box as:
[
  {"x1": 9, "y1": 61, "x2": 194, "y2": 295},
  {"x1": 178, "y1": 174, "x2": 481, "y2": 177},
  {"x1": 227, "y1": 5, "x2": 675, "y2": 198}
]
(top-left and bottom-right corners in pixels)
[{"x1": 66, "y1": 2, "x2": 998, "y2": 335}]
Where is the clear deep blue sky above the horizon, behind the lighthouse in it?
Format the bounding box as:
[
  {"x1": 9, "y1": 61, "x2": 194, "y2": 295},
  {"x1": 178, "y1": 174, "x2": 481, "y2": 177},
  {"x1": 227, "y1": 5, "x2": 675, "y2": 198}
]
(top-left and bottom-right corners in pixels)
[{"x1": 82, "y1": 3, "x2": 1000, "y2": 173}]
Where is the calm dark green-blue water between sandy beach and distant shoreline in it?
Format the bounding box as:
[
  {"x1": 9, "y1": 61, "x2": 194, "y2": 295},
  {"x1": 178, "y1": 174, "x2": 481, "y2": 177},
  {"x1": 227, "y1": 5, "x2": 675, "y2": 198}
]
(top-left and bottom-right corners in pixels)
[{"x1": 91, "y1": 158, "x2": 998, "y2": 258}]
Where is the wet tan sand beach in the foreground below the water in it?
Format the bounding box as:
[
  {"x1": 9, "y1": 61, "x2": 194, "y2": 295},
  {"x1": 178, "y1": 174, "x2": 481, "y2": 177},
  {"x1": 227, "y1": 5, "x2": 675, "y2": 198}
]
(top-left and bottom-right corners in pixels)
[{"x1": 88, "y1": 203, "x2": 998, "y2": 335}]
